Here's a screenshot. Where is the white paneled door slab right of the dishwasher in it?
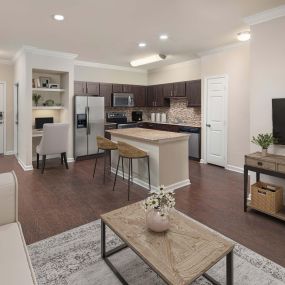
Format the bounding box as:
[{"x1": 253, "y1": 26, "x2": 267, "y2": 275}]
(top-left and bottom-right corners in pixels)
[{"x1": 206, "y1": 76, "x2": 227, "y2": 167}]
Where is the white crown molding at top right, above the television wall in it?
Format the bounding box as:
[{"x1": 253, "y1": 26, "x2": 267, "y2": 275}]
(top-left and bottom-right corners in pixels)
[{"x1": 243, "y1": 5, "x2": 285, "y2": 26}]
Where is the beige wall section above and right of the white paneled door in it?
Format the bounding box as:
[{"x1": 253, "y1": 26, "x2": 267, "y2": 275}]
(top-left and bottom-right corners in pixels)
[{"x1": 201, "y1": 44, "x2": 250, "y2": 167}]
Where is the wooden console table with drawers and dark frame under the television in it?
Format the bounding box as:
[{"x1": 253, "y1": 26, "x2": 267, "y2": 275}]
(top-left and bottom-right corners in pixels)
[{"x1": 244, "y1": 152, "x2": 285, "y2": 221}]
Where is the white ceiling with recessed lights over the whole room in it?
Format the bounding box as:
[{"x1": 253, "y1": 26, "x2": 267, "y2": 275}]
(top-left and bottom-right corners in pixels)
[{"x1": 0, "y1": 0, "x2": 285, "y2": 68}]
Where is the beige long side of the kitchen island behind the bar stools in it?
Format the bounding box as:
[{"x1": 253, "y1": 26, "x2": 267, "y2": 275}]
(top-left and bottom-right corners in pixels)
[{"x1": 111, "y1": 134, "x2": 160, "y2": 190}]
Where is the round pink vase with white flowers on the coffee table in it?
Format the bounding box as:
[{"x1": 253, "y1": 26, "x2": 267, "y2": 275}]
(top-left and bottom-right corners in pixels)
[{"x1": 144, "y1": 185, "x2": 175, "y2": 233}]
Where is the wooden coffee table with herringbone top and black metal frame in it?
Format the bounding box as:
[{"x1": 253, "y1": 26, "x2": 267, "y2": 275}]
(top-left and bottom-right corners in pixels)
[{"x1": 101, "y1": 202, "x2": 234, "y2": 285}]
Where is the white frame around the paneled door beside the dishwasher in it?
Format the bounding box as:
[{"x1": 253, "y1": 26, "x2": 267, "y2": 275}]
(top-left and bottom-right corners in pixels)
[{"x1": 200, "y1": 74, "x2": 229, "y2": 168}]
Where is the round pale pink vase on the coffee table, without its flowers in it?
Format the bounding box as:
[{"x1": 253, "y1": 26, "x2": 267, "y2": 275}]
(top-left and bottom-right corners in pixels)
[{"x1": 146, "y1": 209, "x2": 170, "y2": 233}]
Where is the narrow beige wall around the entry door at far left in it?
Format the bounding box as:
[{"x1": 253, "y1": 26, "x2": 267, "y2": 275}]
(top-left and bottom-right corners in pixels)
[{"x1": 0, "y1": 61, "x2": 14, "y2": 152}]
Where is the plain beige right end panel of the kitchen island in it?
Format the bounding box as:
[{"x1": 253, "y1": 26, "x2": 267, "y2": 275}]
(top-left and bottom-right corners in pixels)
[{"x1": 159, "y1": 138, "x2": 190, "y2": 190}]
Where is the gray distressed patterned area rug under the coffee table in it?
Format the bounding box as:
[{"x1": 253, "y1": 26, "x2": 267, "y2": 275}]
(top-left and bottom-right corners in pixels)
[{"x1": 28, "y1": 217, "x2": 285, "y2": 285}]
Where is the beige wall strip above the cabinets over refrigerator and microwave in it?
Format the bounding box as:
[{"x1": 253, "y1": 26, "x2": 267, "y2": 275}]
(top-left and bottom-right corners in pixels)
[{"x1": 74, "y1": 65, "x2": 147, "y2": 85}]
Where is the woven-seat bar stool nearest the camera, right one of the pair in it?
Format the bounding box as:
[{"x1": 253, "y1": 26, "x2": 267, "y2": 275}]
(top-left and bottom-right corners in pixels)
[{"x1": 113, "y1": 141, "x2": 151, "y2": 201}]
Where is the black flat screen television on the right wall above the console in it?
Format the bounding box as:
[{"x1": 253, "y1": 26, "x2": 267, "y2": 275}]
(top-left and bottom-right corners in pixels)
[{"x1": 272, "y1": 98, "x2": 285, "y2": 145}]
